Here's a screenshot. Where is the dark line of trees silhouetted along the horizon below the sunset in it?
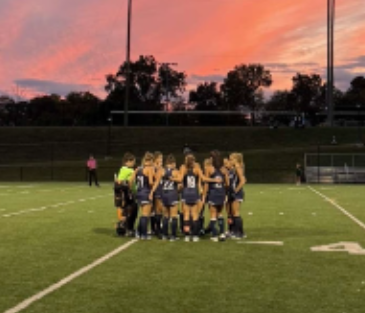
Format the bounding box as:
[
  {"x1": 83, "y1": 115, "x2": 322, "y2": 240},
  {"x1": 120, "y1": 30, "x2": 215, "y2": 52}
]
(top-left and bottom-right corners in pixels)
[{"x1": 0, "y1": 56, "x2": 365, "y2": 126}]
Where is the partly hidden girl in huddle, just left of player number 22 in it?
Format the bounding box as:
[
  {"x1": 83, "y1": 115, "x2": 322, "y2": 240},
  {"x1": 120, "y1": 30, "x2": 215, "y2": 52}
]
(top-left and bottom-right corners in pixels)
[{"x1": 151, "y1": 151, "x2": 163, "y2": 237}]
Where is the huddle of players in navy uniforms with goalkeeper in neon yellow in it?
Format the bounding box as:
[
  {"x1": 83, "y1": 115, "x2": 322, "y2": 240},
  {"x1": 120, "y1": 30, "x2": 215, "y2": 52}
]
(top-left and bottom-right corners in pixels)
[{"x1": 114, "y1": 150, "x2": 246, "y2": 242}]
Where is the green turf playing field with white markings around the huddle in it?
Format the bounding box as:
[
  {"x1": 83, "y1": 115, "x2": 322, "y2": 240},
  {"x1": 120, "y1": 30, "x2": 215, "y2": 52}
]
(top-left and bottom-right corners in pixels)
[{"x1": 0, "y1": 183, "x2": 365, "y2": 313}]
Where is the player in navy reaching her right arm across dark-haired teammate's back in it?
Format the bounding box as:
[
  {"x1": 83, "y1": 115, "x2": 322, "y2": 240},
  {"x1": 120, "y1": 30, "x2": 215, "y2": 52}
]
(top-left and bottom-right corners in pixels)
[{"x1": 180, "y1": 154, "x2": 222, "y2": 242}]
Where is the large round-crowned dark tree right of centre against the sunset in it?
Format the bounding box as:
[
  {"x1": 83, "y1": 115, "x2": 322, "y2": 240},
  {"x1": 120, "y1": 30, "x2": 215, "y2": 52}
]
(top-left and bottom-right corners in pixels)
[{"x1": 221, "y1": 64, "x2": 272, "y2": 111}]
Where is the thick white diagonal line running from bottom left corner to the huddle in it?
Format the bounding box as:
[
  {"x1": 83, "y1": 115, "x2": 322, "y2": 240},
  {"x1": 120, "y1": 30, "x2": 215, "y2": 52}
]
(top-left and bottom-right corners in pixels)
[{"x1": 4, "y1": 239, "x2": 137, "y2": 313}]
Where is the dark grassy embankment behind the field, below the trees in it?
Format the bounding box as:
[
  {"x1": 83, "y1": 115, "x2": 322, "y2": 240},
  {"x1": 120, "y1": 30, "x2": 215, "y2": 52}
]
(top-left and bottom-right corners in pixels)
[{"x1": 0, "y1": 127, "x2": 363, "y2": 182}]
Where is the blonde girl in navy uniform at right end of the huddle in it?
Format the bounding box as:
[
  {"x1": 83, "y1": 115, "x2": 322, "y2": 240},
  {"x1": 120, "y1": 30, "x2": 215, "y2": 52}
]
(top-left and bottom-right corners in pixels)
[{"x1": 229, "y1": 153, "x2": 246, "y2": 239}]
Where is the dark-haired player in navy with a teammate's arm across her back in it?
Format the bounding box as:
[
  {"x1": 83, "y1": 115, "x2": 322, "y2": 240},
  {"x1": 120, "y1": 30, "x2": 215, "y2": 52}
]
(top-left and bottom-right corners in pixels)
[{"x1": 204, "y1": 150, "x2": 229, "y2": 241}]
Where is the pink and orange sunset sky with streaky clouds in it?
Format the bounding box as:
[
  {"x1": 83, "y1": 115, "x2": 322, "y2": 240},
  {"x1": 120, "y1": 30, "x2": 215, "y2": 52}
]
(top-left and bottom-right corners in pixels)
[{"x1": 0, "y1": 0, "x2": 365, "y2": 98}]
